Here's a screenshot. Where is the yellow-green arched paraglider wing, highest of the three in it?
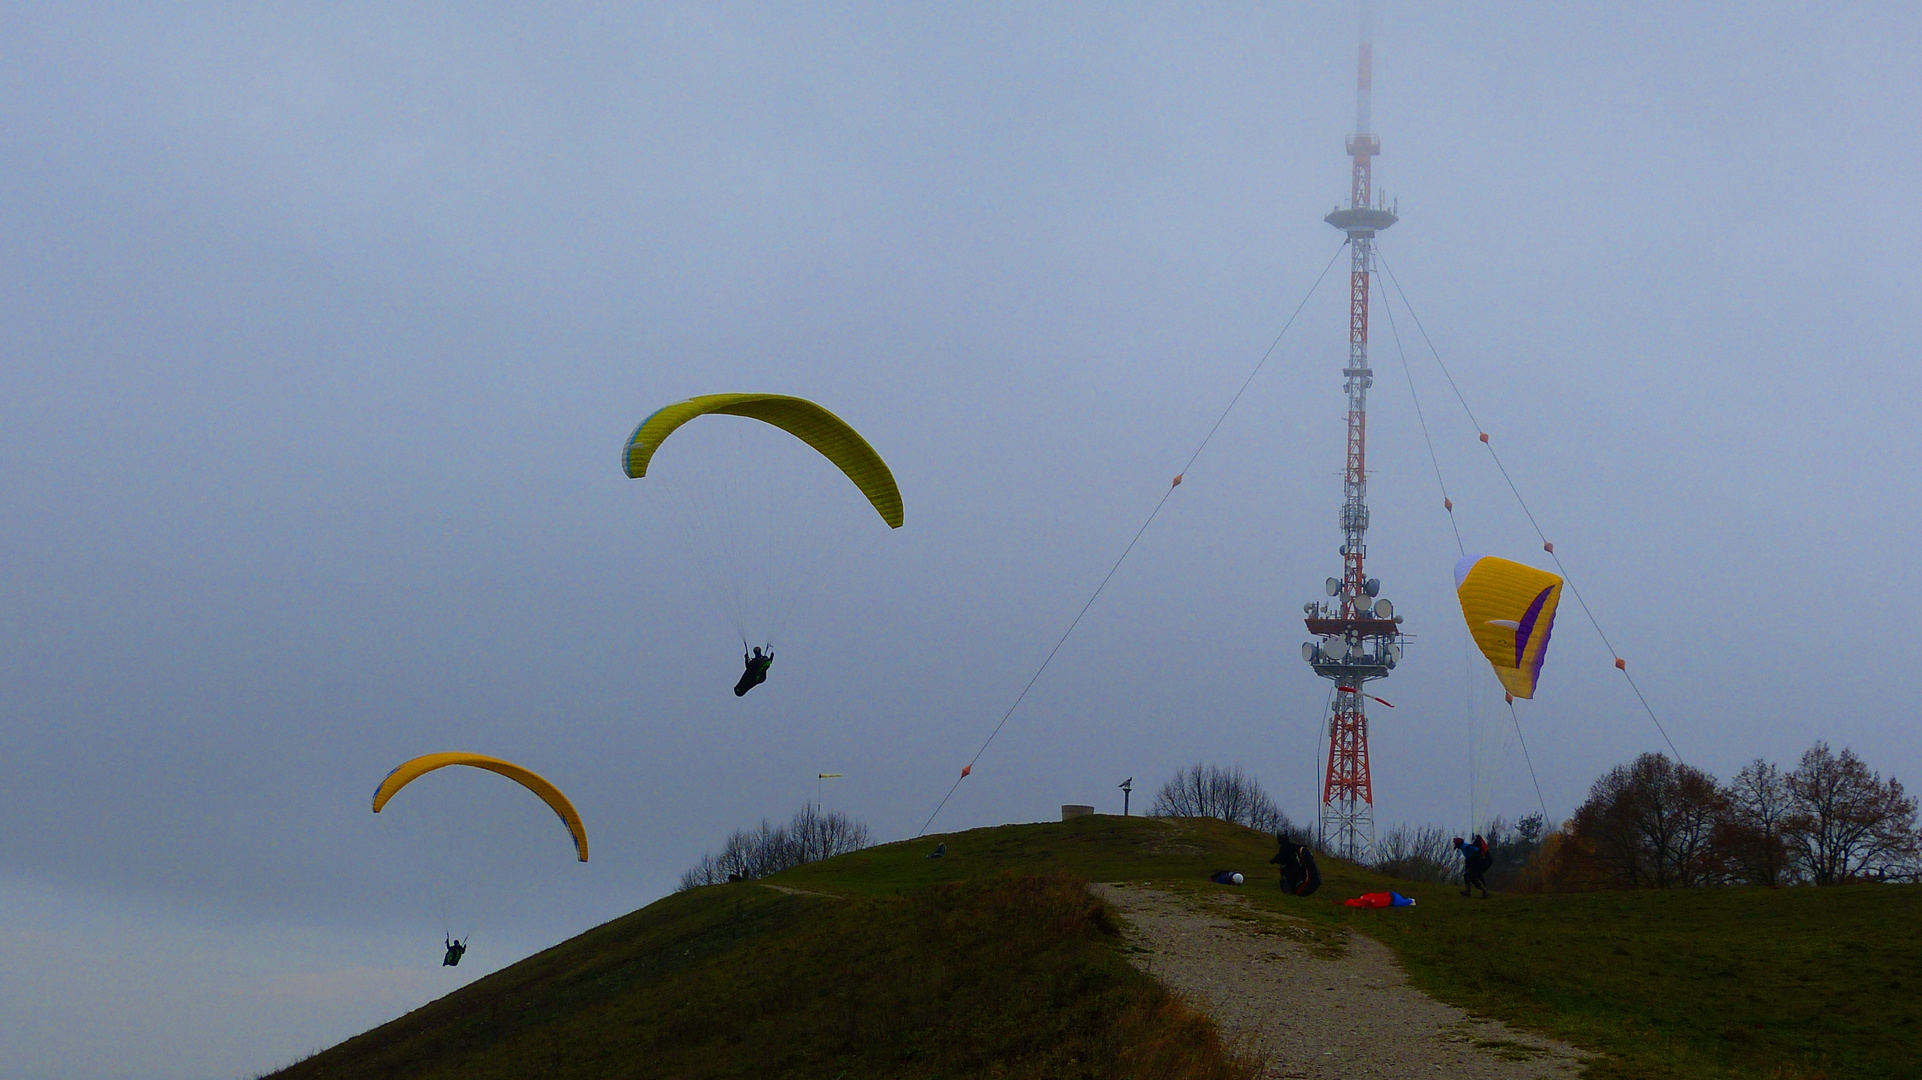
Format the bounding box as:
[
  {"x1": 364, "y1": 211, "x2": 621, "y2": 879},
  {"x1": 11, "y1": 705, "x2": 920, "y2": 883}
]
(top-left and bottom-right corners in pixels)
[{"x1": 621, "y1": 394, "x2": 901, "y2": 528}]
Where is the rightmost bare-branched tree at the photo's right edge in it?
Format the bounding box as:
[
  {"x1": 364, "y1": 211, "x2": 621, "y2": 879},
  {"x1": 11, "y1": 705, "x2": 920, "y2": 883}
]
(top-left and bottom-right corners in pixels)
[{"x1": 1782, "y1": 742, "x2": 1918, "y2": 886}]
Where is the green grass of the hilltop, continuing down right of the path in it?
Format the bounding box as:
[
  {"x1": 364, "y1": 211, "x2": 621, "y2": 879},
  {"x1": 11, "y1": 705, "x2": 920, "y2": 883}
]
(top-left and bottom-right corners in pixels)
[{"x1": 780, "y1": 817, "x2": 1922, "y2": 1080}]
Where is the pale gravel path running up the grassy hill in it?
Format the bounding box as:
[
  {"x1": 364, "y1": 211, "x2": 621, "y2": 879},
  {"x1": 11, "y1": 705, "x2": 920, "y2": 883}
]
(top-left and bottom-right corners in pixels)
[{"x1": 1090, "y1": 882, "x2": 1582, "y2": 1080}]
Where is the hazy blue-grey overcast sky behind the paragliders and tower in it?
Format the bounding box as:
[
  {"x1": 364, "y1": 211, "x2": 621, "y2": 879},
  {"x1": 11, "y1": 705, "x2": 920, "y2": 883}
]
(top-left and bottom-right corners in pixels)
[{"x1": 0, "y1": 2, "x2": 1922, "y2": 1080}]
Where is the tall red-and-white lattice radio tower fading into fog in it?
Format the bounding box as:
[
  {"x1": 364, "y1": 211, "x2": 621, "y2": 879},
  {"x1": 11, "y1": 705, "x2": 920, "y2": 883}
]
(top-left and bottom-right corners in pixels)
[{"x1": 1301, "y1": 0, "x2": 1401, "y2": 859}]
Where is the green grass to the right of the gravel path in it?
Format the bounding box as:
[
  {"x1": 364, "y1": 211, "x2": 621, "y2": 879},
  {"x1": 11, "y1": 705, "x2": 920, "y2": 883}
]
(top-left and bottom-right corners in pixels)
[{"x1": 1353, "y1": 868, "x2": 1922, "y2": 1078}]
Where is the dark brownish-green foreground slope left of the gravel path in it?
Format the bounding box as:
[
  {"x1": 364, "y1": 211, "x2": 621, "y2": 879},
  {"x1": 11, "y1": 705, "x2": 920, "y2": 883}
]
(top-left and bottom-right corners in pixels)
[{"x1": 275, "y1": 874, "x2": 1253, "y2": 1080}]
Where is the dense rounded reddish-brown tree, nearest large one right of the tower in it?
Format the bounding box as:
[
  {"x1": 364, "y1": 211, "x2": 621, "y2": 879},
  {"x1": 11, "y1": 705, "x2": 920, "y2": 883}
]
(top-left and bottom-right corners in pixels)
[{"x1": 1566, "y1": 753, "x2": 1726, "y2": 888}]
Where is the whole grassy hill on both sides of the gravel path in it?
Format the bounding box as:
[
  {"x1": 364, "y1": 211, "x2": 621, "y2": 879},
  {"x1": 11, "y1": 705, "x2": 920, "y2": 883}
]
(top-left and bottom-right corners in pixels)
[{"x1": 277, "y1": 817, "x2": 1922, "y2": 1080}]
